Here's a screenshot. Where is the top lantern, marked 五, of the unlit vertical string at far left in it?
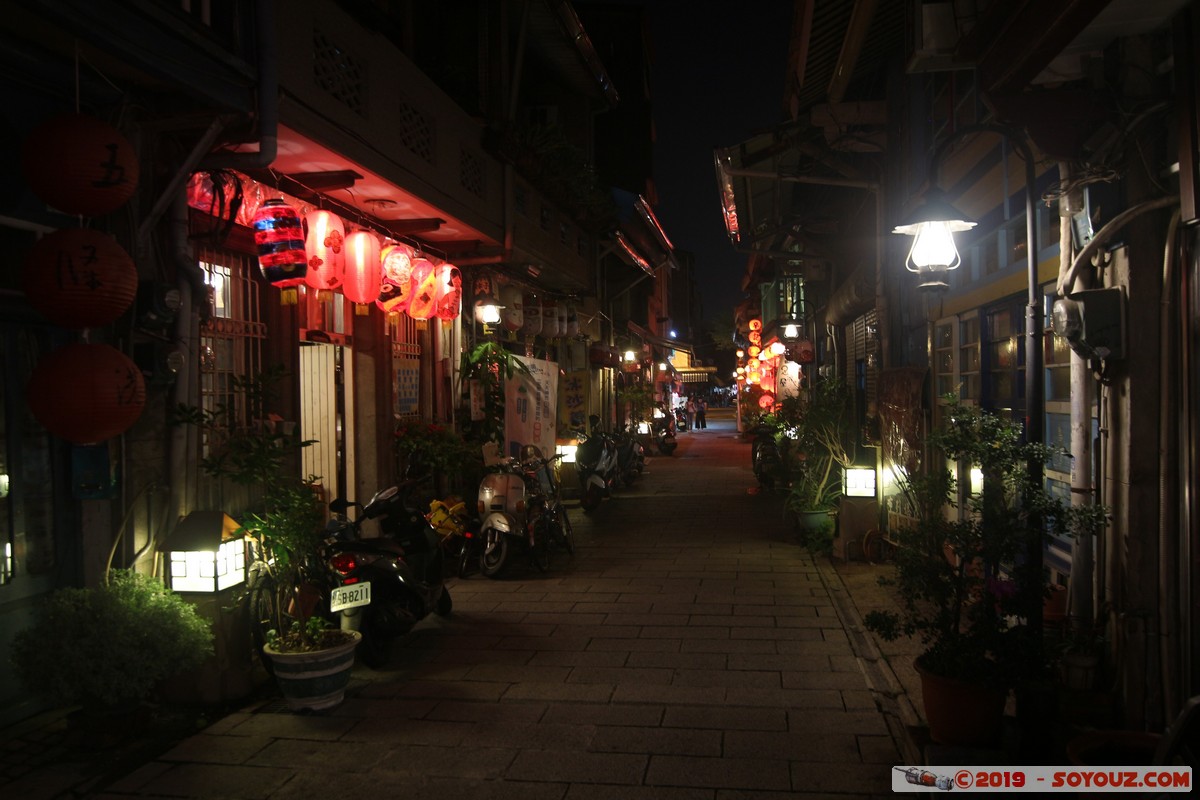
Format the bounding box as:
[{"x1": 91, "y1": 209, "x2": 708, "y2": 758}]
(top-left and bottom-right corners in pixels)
[{"x1": 20, "y1": 114, "x2": 138, "y2": 217}]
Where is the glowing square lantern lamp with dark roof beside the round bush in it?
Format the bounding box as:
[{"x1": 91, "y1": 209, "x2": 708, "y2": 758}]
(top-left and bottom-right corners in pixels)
[{"x1": 160, "y1": 511, "x2": 247, "y2": 594}]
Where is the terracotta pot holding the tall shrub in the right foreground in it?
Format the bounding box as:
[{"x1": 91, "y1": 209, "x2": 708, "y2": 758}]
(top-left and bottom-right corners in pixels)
[{"x1": 913, "y1": 657, "x2": 1008, "y2": 746}]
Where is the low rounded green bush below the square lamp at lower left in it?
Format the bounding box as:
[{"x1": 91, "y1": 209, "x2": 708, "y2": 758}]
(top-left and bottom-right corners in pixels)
[{"x1": 12, "y1": 570, "x2": 212, "y2": 735}]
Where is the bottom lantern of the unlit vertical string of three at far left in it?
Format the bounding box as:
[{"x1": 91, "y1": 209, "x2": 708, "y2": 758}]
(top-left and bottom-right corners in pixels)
[{"x1": 26, "y1": 343, "x2": 146, "y2": 445}]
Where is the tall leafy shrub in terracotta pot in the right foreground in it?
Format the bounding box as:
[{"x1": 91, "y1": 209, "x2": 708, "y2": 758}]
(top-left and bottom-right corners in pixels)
[{"x1": 863, "y1": 397, "x2": 1100, "y2": 745}]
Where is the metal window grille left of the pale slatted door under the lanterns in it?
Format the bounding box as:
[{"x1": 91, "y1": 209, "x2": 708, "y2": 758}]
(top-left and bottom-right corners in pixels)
[{"x1": 198, "y1": 248, "x2": 266, "y2": 507}]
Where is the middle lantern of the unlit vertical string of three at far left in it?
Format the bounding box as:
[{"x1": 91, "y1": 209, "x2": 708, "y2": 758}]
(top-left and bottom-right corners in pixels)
[{"x1": 22, "y1": 228, "x2": 138, "y2": 327}]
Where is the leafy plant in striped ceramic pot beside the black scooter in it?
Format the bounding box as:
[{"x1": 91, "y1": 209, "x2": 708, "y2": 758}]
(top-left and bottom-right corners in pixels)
[{"x1": 175, "y1": 367, "x2": 361, "y2": 710}]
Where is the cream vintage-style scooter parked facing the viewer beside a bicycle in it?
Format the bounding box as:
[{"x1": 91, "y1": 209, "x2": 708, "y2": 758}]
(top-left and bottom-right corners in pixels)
[{"x1": 478, "y1": 445, "x2": 558, "y2": 578}]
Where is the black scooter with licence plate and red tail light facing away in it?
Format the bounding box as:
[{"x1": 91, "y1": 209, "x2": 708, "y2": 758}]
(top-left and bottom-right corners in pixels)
[{"x1": 325, "y1": 481, "x2": 454, "y2": 669}]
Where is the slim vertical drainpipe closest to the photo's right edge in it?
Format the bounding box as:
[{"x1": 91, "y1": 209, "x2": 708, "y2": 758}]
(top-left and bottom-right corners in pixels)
[{"x1": 1158, "y1": 209, "x2": 1182, "y2": 718}]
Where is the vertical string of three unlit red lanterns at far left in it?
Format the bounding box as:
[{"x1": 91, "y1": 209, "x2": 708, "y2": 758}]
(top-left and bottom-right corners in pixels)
[{"x1": 22, "y1": 114, "x2": 145, "y2": 445}]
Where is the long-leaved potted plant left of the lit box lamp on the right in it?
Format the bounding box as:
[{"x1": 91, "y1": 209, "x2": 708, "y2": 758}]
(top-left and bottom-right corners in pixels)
[{"x1": 775, "y1": 380, "x2": 854, "y2": 549}]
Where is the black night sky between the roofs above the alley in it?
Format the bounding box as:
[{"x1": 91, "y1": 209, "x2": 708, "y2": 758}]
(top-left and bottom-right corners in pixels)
[{"x1": 644, "y1": 0, "x2": 792, "y2": 319}]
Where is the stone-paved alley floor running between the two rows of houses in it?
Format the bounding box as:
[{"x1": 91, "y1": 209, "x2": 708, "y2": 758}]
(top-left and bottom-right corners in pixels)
[{"x1": 5, "y1": 415, "x2": 916, "y2": 800}]
